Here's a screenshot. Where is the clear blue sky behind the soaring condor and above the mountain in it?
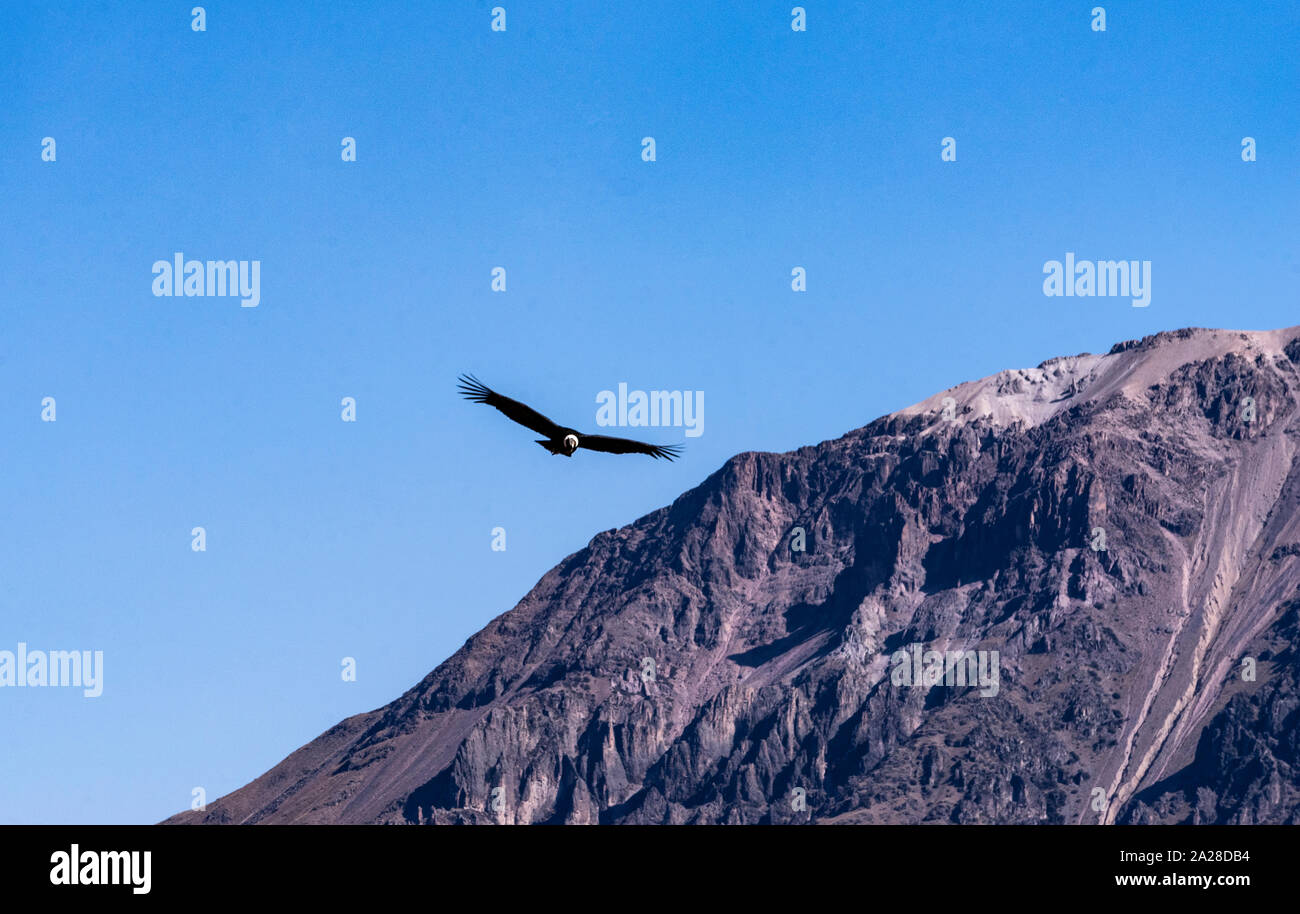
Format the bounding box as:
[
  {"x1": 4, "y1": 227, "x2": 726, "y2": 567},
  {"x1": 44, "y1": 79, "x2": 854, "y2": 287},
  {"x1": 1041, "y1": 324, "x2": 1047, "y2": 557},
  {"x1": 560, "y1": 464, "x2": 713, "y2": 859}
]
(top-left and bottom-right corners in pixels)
[{"x1": 0, "y1": 0, "x2": 1300, "y2": 823}]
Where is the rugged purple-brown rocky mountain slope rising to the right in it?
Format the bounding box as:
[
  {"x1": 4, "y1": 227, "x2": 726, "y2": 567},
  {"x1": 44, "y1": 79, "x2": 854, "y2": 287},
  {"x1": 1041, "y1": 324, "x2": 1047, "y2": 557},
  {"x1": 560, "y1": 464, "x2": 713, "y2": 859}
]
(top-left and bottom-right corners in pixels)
[{"x1": 170, "y1": 328, "x2": 1300, "y2": 823}]
